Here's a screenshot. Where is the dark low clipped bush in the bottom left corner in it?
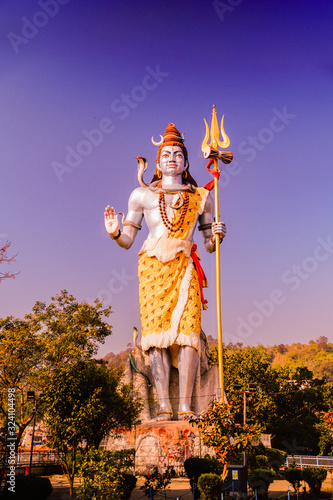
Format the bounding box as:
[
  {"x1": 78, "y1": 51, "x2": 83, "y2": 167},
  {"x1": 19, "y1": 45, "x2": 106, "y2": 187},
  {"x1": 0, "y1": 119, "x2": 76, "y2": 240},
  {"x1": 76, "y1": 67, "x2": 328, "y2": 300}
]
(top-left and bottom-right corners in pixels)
[{"x1": 4, "y1": 475, "x2": 52, "y2": 500}]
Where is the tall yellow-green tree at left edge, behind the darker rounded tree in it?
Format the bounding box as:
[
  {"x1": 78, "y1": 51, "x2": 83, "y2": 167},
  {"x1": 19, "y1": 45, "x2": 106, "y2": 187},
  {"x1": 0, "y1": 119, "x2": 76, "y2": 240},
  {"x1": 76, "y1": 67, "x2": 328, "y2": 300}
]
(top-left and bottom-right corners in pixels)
[{"x1": 0, "y1": 290, "x2": 112, "y2": 446}]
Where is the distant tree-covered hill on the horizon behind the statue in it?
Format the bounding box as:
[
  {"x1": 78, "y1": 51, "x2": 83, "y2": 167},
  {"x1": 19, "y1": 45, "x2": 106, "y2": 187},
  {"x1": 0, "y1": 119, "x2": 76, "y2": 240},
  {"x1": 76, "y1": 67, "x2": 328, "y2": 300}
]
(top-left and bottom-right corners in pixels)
[{"x1": 103, "y1": 335, "x2": 333, "y2": 382}]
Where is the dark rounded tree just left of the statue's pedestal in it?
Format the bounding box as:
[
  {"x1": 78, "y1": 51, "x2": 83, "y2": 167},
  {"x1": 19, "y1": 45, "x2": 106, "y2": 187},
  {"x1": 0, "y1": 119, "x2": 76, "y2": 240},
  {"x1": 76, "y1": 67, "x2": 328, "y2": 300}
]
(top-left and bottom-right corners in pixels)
[{"x1": 43, "y1": 360, "x2": 141, "y2": 496}]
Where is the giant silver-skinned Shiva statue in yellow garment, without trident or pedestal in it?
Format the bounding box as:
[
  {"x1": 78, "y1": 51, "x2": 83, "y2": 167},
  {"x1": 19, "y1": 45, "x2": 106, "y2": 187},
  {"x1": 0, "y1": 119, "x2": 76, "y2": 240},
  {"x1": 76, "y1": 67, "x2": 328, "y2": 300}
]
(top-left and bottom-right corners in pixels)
[{"x1": 104, "y1": 123, "x2": 226, "y2": 420}]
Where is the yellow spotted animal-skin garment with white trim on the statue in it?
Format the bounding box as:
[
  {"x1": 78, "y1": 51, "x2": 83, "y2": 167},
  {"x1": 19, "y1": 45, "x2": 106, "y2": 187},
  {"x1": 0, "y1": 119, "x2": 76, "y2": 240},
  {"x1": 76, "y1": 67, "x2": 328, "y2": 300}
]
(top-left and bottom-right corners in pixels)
[{"x1": 139, "y1": 188, "x2": 208, "y2": 360}]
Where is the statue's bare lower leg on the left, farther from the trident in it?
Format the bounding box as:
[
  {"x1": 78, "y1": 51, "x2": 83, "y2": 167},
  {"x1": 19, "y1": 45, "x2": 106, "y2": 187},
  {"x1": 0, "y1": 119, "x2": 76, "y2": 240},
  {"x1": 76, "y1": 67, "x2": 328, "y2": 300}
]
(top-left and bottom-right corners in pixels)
[{"x1": 149, "y1": 347, "x2": 172, "y2": 420}]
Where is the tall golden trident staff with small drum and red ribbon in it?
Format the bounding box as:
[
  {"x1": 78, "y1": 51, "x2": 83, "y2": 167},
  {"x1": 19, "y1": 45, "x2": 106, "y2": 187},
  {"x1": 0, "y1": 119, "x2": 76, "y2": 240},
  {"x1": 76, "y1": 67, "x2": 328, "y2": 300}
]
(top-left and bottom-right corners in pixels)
[{"x1": 201, "y1": 104, "x2": 233, "y2": 402}]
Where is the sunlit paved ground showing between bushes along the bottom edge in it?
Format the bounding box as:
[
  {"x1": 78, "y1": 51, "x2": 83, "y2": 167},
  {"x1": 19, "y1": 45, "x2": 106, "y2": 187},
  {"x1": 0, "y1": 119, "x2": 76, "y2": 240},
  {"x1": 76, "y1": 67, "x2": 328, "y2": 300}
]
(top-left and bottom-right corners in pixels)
[{"x1": 48, "y1": 476, "x2": 333, "y2": 500}]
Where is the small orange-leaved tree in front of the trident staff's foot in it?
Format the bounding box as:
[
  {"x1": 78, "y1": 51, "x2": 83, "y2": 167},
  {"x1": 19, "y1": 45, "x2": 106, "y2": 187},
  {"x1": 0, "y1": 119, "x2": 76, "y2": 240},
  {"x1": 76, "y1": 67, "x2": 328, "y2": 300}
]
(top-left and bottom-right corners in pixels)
[{"x1": 190, "y1": 400, "x2": 262, "y2": 481}]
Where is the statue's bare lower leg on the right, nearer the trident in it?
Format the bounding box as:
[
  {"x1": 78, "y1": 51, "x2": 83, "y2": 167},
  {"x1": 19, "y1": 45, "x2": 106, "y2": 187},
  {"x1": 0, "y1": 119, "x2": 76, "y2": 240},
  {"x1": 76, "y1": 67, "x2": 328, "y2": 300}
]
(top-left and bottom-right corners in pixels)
[{"x1": 178, "y1": 346, "x2": 199, "y2": 420}]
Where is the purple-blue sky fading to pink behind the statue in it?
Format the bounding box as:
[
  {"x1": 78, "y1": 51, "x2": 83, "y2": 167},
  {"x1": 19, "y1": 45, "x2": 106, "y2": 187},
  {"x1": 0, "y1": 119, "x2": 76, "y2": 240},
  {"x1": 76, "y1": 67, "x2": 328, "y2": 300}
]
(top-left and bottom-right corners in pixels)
[{"x1": 0, "y1": 0, "x2": 333, "y2": 355}]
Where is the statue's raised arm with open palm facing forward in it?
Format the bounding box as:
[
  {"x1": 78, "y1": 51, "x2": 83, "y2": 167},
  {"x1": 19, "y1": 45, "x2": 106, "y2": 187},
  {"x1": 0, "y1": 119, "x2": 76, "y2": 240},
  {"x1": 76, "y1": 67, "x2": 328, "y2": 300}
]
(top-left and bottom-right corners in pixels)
[{"x1": 104, "y1": 188, "x2": 143, "y2": 250}]
